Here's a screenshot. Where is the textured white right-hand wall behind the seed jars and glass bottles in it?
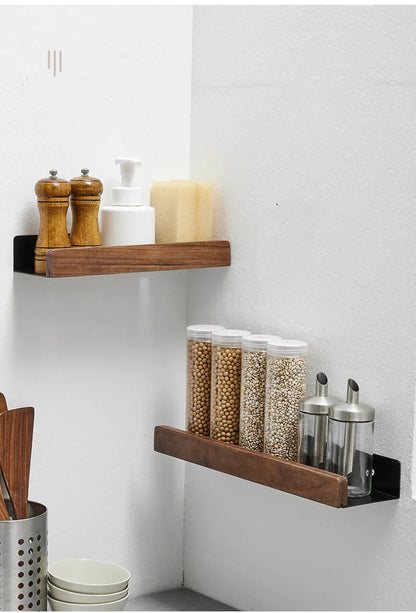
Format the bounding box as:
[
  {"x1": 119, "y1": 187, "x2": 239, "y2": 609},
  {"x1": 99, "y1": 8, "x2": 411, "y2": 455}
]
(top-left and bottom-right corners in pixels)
[{"x1": 185, "y1": 6, "x2": 416, "y2": 610}]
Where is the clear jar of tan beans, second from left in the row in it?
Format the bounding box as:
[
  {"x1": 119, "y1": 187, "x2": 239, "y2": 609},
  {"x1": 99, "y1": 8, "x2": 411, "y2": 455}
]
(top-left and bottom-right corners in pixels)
[{"x1": 211, "y1": 330, "x2": 249, "y2": 445}]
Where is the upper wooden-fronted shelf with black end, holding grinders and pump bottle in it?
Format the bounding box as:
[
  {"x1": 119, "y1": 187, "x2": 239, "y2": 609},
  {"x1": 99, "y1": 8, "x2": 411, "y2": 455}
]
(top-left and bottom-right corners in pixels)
[{"x1": 13, "y1": 235, "x2": 231, "y2": 278}]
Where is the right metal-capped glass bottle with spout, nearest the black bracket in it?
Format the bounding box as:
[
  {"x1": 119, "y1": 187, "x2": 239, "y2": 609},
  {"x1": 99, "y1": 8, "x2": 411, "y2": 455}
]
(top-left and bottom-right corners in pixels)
[{"x1": 326, "y1": 379, "x2": 375, "y2": 498}]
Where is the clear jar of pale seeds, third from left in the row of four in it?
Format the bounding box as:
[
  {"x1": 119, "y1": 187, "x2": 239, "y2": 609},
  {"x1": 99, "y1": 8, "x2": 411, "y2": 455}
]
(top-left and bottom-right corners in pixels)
[{"x1": 239, "y1": 334, "x2": 280, "y2": 451}]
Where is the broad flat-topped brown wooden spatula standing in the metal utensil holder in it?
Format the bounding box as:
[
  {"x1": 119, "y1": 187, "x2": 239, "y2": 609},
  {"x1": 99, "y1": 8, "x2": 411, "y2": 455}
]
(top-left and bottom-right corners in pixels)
[{"x1": 0, "y1": 407, "x2": 35, "y2": 519}]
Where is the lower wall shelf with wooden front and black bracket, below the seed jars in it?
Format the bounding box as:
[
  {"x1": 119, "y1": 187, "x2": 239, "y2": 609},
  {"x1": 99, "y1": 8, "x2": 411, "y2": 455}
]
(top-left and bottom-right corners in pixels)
[{"x1": 154, "y1": 426, "x2": 400, "y2": 508}]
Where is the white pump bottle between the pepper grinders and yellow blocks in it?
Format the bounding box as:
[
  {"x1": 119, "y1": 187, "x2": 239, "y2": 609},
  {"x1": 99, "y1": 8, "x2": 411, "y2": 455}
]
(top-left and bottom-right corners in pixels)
[{"x1": 101, "y1": 157, "x2": 155, "y2": 246}]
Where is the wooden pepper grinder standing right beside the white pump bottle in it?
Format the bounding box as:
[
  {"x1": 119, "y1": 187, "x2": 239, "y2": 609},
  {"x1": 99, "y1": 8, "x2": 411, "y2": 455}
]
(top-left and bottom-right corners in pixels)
[{"x1": 70, "y1": 168, "x2": 103, "y2": 247}]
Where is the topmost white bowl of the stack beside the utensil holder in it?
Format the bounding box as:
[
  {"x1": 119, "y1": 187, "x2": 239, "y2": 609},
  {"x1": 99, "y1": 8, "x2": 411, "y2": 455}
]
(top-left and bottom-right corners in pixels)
[{"x1": 48, "y1": 560, "x2": 130, "y2": 594}]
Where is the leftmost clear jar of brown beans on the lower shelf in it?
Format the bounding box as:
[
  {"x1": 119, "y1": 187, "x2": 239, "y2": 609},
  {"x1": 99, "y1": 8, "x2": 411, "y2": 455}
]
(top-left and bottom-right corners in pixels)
[{"x1": 186, "y1": 325, "x2": 224, "y2": 436}]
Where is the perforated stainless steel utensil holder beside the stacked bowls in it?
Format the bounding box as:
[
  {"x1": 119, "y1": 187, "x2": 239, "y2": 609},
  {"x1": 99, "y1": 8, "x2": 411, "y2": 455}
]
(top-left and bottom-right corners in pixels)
[{"x1": 0, "y1": 500, "x2": 48, "y2": 611}]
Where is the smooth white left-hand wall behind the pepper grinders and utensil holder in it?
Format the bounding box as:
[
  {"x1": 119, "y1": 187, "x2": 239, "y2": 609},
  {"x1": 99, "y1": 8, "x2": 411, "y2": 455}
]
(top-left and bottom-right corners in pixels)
[{"x1": 0, "y1": 6, "x2": 192, "y2": 596}]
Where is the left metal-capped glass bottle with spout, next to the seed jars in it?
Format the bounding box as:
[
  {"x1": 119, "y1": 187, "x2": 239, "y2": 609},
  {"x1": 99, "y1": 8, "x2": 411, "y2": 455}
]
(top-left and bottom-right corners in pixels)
[{"x1": 298, "y1": 372, "x2": 340, "y2": 469}]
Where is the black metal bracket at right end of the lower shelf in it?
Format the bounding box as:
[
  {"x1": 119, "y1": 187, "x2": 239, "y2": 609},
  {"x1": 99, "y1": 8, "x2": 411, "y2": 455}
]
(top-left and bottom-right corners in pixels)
[{"x1": 345, "y1": 454, "x2": 401, "y2": 509}]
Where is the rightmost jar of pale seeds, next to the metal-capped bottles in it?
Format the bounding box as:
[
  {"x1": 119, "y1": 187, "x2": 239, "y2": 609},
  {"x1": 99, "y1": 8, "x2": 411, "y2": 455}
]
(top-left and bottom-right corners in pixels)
[{"x1": 264, "y1": 339, "x2": 308, "y2": 461}]
